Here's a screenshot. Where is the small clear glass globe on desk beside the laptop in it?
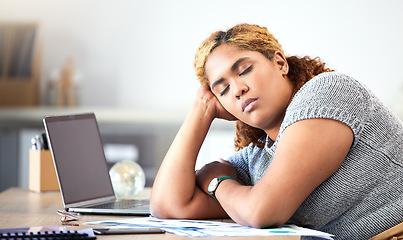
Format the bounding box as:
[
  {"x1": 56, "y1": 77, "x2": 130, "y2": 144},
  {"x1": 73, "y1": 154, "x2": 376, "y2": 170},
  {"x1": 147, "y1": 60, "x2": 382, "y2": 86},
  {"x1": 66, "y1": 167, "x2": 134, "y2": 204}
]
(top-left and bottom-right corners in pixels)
[{"x1": 109, "y1": 160, "x2": 146, "y2": 198}]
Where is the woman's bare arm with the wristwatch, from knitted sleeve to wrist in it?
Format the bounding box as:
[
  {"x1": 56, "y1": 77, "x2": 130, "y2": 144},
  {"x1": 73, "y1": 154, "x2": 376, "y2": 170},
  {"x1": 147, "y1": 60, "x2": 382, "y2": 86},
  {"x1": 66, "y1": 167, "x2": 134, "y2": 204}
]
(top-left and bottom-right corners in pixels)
[{"x1": 202, "y1": 119, "x2": 353, "y2": 228}]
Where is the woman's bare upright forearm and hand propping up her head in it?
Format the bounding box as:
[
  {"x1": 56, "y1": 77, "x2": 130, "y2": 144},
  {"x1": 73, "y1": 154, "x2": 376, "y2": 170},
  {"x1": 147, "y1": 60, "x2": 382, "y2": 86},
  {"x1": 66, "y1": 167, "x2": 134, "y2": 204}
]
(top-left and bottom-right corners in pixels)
[{"x1": 150, "y1": 88, "x2": 233, "y2": 219}]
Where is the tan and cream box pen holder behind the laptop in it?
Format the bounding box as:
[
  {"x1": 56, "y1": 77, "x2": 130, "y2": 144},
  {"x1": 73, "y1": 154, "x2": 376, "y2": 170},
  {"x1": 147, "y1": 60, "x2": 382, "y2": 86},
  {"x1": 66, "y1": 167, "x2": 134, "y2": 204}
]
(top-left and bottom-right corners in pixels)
[{"x1": 29, "y1": 149, "x2": 59, "y2": 192}]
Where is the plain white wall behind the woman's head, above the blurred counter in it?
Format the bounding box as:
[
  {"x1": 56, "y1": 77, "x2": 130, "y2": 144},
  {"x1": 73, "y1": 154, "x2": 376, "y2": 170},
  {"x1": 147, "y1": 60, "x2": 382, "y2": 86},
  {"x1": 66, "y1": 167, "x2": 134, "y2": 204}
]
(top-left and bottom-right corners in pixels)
[{"x1": 0, "y1": 0, "x2": 403, "y2": 114}]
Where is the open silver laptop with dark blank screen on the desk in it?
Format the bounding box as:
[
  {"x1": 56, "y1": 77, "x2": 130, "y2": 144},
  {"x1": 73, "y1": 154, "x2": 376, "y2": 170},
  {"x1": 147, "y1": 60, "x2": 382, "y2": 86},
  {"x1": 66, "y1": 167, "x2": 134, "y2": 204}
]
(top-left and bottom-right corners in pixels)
[{"x1": 43, "y1": 113, "x2": 150, "y2": 215}]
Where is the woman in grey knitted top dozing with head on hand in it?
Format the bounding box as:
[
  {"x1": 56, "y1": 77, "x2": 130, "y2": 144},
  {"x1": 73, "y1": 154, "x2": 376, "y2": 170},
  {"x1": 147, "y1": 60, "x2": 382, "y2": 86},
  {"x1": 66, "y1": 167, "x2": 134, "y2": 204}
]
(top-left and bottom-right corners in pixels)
[{"x1": 151, "y1": 24, "x2": 403, "y2": 239}]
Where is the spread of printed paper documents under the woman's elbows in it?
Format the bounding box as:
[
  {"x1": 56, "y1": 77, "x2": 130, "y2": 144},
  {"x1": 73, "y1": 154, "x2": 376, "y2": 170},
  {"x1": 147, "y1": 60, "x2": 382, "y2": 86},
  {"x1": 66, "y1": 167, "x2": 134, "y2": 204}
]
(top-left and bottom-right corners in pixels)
[{"x1": 86, "y1": 217, "x2": 333, "y2": 239}]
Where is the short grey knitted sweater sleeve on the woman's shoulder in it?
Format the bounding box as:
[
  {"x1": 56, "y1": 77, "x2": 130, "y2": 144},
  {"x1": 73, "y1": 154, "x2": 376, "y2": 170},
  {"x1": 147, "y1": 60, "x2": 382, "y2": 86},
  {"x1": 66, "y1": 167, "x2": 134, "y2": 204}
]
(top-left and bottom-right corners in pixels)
[{"x1": 279, "y1": 72, "x2": 372, "y2": 146}]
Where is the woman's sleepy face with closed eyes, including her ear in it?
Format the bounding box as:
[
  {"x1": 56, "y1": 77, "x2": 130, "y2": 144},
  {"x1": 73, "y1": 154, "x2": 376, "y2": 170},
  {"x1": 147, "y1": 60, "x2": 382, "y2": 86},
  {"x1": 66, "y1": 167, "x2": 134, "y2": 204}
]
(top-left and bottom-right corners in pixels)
[{"x1": 205, "y1": 44, "x2": 293, "y2": 136}]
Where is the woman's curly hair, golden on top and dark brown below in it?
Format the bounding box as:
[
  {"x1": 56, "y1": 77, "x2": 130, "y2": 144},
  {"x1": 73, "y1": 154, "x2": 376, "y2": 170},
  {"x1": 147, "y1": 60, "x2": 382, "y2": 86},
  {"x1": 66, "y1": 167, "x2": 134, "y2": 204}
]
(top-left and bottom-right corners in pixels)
[{"x1": 194, "y1": 24, "x2": 332, "y2": 151}]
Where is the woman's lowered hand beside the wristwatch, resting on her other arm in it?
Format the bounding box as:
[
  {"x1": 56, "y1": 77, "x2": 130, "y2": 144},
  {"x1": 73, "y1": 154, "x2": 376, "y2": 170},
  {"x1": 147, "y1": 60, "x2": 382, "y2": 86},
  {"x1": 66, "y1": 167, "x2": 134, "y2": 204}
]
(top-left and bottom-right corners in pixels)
[{"x1": 196, "y1": 159, "x2": 239, "y2": 194}]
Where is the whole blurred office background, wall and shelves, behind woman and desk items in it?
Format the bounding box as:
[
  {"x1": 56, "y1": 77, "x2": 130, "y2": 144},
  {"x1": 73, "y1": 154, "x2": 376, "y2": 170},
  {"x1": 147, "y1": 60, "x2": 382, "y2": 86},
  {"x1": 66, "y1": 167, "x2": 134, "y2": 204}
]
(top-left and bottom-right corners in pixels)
[{"x1": 0, "y1": 0, "x2": 403, "y2": 191}]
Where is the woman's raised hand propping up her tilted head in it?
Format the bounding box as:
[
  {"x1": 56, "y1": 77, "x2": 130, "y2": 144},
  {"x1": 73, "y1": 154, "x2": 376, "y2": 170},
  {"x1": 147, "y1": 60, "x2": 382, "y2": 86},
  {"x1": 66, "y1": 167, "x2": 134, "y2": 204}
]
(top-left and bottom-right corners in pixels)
[{"x1": 196, "y1": 87, "x2": 237, "y2": 121}]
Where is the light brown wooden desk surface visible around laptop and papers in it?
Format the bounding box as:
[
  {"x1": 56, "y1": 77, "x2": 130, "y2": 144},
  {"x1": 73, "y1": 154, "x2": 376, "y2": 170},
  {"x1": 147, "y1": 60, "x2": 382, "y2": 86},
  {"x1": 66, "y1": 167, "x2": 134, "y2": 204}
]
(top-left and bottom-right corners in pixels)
[{"x1": 0, "y1": 188, "x2": 300, "y2": 240}]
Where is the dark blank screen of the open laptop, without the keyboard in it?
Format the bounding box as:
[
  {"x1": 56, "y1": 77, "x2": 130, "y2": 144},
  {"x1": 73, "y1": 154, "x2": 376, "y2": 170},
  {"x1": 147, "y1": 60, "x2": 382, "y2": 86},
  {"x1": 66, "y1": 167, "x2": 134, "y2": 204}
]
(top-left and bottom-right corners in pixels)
[{"x1": 44, "y1": 113, "x2": 114, "y2": 204}]
